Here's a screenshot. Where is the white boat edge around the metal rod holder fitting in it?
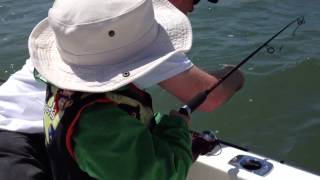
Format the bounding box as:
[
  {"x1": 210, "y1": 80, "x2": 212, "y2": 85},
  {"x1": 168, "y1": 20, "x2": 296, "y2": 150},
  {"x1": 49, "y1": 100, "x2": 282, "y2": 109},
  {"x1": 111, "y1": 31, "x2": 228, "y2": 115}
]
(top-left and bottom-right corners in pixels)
[{"x1": 187, "y1": 145, "x2": 320, "y2": 180}]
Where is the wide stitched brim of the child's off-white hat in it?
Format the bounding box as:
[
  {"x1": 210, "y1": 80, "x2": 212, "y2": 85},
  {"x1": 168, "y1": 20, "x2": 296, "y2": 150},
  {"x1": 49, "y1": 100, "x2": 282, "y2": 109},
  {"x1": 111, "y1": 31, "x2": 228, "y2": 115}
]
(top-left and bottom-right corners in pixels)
[{"x1": 29, "y1": 0, "x2": 192, "y2": 92}]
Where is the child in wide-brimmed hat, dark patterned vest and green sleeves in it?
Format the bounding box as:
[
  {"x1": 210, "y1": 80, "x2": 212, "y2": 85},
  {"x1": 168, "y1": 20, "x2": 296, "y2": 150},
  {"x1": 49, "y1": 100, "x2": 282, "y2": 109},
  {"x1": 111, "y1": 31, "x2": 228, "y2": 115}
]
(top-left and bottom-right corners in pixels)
[{"x1": 29, "y1": 0, "x2": 192, "y2": 180}]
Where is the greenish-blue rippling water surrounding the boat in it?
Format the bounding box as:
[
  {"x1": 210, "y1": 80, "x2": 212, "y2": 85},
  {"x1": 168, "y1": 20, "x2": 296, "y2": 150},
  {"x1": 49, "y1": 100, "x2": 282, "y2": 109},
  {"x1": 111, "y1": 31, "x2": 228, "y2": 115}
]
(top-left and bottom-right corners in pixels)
[{"x1": 0, "y1": 0, "x2": 320, "y2": 172}]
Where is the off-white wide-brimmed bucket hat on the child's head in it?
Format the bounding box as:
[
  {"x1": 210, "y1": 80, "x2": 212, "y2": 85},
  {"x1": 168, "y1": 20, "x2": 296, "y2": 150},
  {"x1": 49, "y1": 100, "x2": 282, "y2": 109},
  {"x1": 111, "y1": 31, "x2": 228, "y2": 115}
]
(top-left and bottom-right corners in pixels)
[{"x1": 29, "y1": 0, "x2": 192, "y2": 92}]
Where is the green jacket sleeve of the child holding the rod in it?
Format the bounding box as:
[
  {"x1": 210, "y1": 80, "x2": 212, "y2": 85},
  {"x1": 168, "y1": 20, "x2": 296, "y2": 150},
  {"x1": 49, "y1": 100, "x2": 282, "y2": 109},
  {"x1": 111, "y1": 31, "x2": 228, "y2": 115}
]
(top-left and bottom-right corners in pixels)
[{"x1": 73, "y1": 104, "x2": 192, "y2": 180}]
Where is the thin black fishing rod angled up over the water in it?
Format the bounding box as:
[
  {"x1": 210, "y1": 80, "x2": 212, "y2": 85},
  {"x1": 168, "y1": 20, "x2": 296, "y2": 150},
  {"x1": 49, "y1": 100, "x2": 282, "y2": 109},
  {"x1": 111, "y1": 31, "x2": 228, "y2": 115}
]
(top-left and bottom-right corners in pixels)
[{"x1": 179, "y1": 16, "x2": 305, "y2": 116}]
